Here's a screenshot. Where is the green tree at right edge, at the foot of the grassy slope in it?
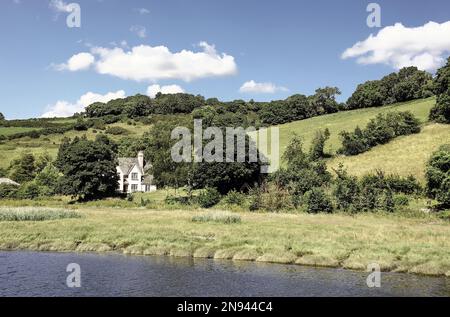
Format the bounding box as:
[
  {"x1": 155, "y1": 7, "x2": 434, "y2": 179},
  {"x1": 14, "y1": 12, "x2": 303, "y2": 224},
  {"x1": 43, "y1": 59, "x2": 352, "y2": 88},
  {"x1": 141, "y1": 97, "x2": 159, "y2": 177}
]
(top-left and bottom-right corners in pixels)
[{"x1": 426, "y1": 144, "x2": 450, "y2": 207}]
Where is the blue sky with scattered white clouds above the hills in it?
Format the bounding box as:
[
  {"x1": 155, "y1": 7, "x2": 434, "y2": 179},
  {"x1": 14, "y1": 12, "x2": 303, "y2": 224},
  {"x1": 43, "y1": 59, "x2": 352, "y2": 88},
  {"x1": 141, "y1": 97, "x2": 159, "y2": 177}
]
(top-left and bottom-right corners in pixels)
[{"x1": 0, "y1": 0, "x2": 450, "y2": 119}]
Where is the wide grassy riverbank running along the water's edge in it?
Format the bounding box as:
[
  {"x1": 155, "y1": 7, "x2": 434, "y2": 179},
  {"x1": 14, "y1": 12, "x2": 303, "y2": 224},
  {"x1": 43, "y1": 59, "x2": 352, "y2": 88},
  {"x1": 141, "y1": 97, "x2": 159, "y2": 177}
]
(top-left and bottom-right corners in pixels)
[{"x1": 0, "y1": 208, "x2": 450, "y2": 276}]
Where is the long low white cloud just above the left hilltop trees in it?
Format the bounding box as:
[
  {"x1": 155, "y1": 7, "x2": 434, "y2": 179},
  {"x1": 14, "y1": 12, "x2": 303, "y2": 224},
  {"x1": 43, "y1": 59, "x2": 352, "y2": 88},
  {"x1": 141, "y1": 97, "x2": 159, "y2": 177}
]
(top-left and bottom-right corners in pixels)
[{"x1": 42, "y1": 90, "x2": 126, "y2": 118}]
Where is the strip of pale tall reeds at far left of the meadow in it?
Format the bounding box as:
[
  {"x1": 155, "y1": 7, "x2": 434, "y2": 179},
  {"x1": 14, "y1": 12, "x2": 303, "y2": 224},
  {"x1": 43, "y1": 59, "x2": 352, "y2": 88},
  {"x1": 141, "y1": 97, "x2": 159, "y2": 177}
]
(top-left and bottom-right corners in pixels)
[{"x1": 0, "y1": 207, "x2": 81, "y2": 221}]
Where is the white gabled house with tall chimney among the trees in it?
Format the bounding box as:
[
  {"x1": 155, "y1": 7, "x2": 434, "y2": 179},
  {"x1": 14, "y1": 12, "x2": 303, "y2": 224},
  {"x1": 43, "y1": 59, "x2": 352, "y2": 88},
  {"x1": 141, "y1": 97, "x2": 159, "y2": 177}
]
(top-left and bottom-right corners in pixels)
[{"x1": 117, "y1": 152, "x2": 156, "y2": 193}]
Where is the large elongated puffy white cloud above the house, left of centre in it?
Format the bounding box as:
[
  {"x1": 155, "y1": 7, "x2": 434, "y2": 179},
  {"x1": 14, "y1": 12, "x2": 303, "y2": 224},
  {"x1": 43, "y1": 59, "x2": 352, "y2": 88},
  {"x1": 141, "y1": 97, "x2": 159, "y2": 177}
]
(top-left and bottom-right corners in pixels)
[{"x1": 57, "y1": 42, "x2": 237, "y2": 82}]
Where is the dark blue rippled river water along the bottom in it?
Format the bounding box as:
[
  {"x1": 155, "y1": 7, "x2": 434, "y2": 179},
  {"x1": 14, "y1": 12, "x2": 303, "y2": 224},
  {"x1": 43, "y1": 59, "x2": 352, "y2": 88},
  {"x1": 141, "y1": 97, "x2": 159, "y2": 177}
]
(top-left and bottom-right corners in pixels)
[{"x1": 0, "y1": 252, "x2": 450, "y2": 297}]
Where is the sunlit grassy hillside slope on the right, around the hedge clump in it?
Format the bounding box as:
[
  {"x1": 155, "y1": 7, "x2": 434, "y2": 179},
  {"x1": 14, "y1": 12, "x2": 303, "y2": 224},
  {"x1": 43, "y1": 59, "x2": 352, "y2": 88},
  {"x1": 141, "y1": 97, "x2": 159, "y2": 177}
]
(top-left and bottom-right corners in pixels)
[{"x1": 279, "y1": 98, "x2": 450, "y2": 180}]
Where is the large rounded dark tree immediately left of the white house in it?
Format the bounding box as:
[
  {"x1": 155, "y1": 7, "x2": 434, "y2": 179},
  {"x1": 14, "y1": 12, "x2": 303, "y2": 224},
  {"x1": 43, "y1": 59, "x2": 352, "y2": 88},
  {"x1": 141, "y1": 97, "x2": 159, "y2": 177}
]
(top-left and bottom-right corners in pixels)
[{"x1": 55, "y1": 136, "x2": 119, "y2": 200}]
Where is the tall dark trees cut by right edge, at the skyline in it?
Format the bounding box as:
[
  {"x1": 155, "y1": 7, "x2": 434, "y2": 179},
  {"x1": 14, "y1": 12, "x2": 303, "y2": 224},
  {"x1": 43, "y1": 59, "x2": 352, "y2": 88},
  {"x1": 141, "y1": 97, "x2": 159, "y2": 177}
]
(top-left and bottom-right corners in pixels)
[{"x1": 430, "y1": 57, "x2": 450, "y2": 123}]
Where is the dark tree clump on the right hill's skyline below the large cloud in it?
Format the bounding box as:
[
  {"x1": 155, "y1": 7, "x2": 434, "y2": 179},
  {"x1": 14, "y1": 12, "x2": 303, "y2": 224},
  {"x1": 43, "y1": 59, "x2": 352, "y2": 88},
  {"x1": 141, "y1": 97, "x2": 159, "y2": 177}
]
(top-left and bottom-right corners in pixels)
[{"x1": 345, "y1": 66, "x2": 434, "y2": 110}]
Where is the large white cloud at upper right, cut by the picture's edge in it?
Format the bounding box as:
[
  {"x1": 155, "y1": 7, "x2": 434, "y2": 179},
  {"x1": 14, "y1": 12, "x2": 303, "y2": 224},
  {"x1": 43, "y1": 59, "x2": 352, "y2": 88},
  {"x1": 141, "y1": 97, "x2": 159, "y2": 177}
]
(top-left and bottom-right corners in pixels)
[{"x1": 342, "y1": 21, "x2": 450, "y2": 71}]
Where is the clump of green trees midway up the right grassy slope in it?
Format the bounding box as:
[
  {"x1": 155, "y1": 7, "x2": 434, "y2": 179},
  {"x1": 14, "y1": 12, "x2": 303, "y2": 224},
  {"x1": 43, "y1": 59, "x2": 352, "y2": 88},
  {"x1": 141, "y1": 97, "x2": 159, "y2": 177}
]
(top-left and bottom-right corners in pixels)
[{"x1": 338, "y1": 111, "x2": 421, "y2": 155}]
